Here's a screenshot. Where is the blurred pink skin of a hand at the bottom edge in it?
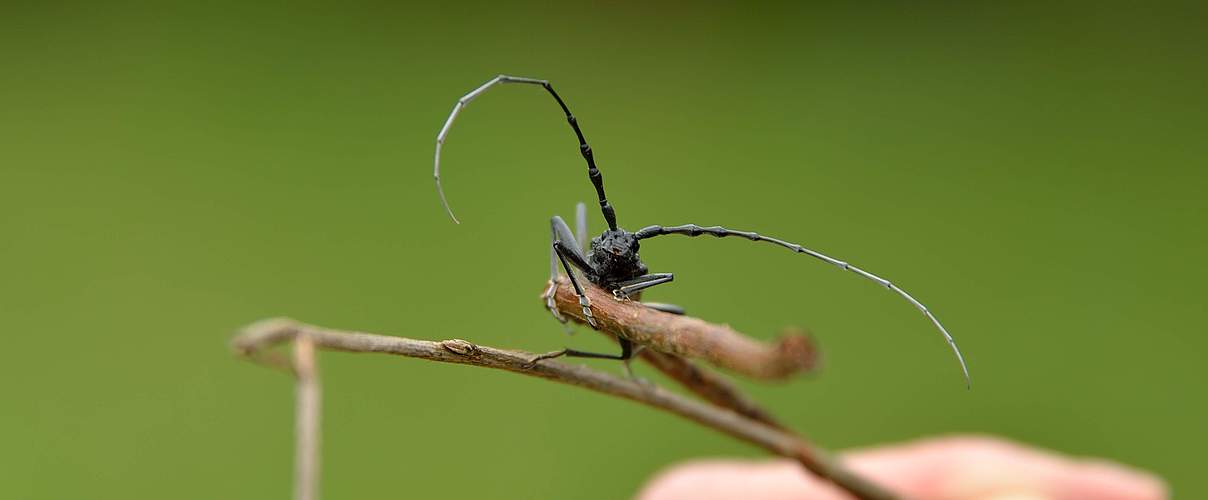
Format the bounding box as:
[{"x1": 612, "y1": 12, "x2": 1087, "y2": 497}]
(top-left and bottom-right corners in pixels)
[{"x1": 638, "y1": 436, "x2": 1168, "y2": 500}]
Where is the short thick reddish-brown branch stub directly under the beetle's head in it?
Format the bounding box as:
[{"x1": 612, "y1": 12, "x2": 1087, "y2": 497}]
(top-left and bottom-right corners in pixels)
[{"x1": 554, "y1": 278, "x2": 818, "y2": 379}]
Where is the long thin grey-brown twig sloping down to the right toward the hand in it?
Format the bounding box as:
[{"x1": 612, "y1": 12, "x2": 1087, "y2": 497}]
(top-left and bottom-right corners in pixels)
[{"x1": 232, "y1": 319, "x2": 898, "y2": 499}]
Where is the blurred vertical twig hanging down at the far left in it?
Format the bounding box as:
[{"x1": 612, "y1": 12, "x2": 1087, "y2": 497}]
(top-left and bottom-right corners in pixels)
[{"x1": 294, "y1": 335, "x2": 320, "y2": 500}]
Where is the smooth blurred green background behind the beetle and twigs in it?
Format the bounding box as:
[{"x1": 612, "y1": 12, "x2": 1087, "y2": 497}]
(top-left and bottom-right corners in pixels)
[{"x1": 0, "y1": 2, "x2": 1208, "y2": 499}]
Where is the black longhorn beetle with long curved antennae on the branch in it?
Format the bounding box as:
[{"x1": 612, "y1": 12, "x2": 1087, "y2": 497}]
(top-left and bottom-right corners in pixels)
[{"x1": 432, "y1": 75, "x2": 970, "y2": 386}]
